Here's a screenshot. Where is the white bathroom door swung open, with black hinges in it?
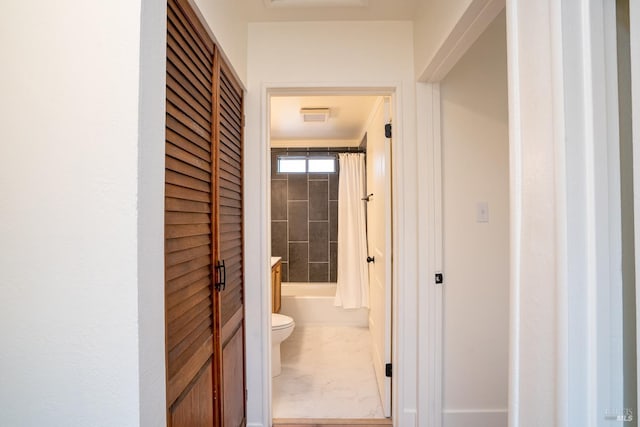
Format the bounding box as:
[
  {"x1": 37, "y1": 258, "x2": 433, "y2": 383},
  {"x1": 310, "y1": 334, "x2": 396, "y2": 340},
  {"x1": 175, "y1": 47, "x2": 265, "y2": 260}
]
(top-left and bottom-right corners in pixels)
[{"x1": 367, "y1": 98, "x2": 392, "y2": 417}]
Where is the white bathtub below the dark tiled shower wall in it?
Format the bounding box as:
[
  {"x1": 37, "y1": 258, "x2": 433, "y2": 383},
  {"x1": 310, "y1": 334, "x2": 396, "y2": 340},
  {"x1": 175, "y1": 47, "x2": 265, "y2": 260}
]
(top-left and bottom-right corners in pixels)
[{"x1": 280, "y1": 282, "x2": 369, "y2": 327}]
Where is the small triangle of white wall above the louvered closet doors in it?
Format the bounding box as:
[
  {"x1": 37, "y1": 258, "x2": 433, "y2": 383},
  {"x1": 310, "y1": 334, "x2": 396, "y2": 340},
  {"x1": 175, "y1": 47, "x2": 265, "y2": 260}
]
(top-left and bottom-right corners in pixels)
[{"x1": 191, "y1": 0, "x2": 247, "y2": 85}]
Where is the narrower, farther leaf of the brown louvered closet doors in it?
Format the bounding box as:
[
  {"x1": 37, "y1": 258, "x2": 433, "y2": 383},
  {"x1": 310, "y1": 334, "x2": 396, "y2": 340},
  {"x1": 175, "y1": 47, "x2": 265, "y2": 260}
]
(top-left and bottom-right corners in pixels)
[{"x1": 216, "y1": 51, "x2": 246, "y2": 427}]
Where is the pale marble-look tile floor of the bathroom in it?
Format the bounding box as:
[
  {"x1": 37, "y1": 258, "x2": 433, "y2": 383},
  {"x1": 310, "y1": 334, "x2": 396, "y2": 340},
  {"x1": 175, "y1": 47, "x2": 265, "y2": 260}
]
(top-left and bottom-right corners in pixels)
[{"x1": 273, "y1": 326, "x2": 383, "y2": 418}]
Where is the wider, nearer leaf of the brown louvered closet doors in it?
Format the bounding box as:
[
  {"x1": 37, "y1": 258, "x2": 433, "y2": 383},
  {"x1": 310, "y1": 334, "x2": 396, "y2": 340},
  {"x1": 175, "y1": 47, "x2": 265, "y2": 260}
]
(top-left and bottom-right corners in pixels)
[{"x1": 165, "y1": 0, "x2": 234, "y2": 427}]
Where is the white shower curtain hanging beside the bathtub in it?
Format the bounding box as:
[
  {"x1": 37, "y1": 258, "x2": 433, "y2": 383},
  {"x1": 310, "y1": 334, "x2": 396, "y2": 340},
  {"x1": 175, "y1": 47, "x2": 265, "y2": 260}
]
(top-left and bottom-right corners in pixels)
[{"x1": 334, "y1": 153, "x2": 369, "y2": 308}]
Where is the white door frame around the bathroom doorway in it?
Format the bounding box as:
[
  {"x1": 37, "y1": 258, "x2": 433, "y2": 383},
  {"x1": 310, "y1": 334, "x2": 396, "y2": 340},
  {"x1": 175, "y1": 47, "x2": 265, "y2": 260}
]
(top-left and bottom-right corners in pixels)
[{"x1": 255, "y1": 82, "x2": 400, "y2": 425}]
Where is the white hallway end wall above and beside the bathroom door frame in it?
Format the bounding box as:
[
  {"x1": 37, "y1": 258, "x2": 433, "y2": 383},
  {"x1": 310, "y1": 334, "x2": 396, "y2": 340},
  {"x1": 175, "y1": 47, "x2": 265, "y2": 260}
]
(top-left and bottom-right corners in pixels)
[{"x1": 245, "y1": 22, "x2": 417, "y2": 426}]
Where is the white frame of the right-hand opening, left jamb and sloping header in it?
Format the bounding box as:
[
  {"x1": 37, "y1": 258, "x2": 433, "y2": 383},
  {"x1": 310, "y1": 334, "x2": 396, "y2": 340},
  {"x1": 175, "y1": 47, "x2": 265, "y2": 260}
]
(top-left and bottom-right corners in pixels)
[{"x1": 416, "y1": 0, "x2": 505, "y2": 427}]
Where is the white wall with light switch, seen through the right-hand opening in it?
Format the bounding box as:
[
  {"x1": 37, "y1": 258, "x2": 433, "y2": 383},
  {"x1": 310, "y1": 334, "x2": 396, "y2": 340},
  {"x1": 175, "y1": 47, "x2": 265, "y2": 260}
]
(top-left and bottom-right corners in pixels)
[{"x1": 441, "y1": 13, "x2": 509, "y2": 427}]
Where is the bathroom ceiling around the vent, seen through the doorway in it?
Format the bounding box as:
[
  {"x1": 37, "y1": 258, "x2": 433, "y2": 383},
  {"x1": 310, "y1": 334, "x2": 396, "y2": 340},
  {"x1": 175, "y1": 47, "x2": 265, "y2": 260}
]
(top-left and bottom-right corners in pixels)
[{"x1": 270, "y1": 95, "x2": 379, "y2": 147}]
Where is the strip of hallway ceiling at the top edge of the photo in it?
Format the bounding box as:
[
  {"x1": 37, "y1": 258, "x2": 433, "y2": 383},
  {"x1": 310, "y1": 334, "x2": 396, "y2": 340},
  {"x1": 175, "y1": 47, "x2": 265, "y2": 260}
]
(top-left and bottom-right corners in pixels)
[{"x1": 245, "y1": 0, "x2": 424, "y2": 22}]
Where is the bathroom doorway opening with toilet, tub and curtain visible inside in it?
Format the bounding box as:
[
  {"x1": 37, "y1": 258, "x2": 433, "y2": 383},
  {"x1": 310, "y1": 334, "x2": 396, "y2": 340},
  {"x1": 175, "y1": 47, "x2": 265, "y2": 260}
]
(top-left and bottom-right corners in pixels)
[{"x1": 267, "y1": 90, "x2": 393, "y2": 425}]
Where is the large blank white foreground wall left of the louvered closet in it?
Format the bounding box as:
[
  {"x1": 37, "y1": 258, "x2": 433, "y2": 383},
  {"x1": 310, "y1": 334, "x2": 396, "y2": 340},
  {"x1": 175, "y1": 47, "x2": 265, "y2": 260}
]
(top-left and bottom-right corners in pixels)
[{"x1": 0, "y1": 0, "x2": 164, "y2": 426}]
